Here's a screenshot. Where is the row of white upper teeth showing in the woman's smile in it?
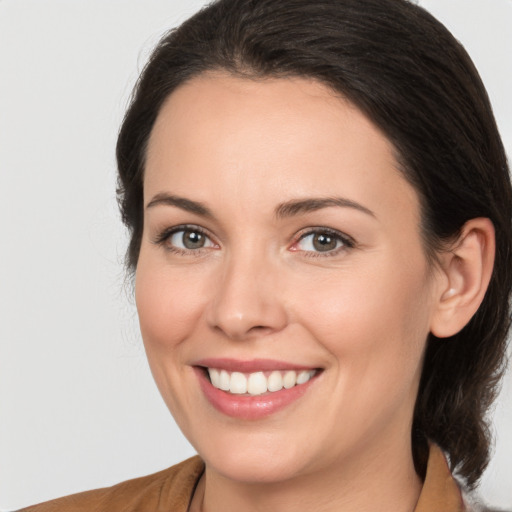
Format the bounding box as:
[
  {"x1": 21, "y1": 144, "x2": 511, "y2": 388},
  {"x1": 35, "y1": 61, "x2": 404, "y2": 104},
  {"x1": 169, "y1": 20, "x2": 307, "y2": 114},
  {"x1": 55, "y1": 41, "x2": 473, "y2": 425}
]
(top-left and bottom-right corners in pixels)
[{"x1": 208, "y1": 368, "x2": 316, "y2": 396}]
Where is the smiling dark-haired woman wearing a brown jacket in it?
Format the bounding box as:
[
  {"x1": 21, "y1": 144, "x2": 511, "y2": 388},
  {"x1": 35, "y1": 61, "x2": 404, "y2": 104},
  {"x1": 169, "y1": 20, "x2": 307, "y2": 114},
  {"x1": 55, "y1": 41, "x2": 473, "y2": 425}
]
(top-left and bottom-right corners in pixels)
[{"x1": 19, "y1": 0, "x2": 512, "y2": 512}]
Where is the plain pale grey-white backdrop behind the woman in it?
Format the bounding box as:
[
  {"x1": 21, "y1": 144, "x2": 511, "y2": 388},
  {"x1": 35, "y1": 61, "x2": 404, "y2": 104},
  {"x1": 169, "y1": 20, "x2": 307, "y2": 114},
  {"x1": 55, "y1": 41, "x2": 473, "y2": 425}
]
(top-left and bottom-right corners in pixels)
[{"x1": 0, "y1": 0, "x2": 512, "y2": 511}]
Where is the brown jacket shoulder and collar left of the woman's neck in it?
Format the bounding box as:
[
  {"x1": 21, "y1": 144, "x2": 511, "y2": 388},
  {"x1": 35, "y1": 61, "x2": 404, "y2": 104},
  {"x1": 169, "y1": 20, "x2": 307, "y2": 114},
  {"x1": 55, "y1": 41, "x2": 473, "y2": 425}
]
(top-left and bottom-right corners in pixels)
[{"x1": 18, "y1": 457, "x2": 204, "y2": 512}]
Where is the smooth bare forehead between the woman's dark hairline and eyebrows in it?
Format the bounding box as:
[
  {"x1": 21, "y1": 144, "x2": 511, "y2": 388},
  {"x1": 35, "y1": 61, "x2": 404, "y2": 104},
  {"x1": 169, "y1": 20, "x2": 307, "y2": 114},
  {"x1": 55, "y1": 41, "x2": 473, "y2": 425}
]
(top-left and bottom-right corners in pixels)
[{"x1": 144, "y1": 74, "x2": 418, "y2": 226}]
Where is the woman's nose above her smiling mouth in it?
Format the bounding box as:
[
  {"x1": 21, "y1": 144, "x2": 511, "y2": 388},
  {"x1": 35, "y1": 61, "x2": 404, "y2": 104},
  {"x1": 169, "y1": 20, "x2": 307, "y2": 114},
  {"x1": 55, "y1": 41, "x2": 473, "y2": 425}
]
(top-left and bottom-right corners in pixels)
[{"x1": 207, "y1": 251, "x2": 287, "y2": 340}]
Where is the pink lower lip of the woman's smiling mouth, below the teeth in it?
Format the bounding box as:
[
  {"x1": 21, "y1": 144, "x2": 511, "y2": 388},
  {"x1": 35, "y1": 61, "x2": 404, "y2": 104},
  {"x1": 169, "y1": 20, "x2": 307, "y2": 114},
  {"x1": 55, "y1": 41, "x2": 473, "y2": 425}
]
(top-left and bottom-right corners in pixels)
[{"x1": 194, "y1": 367, "x2": 316, "y2": 420}]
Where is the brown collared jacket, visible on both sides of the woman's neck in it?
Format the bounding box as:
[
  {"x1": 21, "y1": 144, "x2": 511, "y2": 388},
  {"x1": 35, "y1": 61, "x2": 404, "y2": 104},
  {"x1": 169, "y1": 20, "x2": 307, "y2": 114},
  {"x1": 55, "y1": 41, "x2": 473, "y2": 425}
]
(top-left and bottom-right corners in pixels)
[{"x1": 19, "y1": 446, "x2": 469, "y2": 512}]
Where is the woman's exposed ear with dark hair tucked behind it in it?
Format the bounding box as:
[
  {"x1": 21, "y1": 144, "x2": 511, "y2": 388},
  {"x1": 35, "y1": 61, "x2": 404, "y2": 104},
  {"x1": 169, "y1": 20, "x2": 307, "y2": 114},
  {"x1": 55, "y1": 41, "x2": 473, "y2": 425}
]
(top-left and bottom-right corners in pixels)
[{"x1": 430, "y1": 218, "x2": 495, "y2": 338}]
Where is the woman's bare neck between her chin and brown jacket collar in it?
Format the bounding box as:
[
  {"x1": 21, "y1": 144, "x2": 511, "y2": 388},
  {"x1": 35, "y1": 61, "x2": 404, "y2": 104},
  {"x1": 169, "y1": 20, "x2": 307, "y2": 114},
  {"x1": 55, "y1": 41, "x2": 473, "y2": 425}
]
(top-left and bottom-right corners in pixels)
[{"x1": 190, "y1": 436, "x2": 421, "y2": 512}]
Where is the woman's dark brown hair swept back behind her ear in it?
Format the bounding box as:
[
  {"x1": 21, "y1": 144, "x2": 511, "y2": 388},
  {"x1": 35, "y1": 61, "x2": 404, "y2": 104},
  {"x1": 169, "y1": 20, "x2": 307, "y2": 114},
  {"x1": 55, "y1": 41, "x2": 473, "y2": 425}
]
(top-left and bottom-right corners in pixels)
[{"x1": 117, "y1": 0, "x2": 512, "y2": 487}]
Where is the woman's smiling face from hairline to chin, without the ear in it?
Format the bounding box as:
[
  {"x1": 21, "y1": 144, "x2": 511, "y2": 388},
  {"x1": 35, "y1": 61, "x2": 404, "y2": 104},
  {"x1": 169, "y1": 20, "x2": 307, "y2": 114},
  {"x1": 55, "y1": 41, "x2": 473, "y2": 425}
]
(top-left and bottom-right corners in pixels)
[{"x1": 136, "y1": 74, "x2": 436, "y2": 482}]
